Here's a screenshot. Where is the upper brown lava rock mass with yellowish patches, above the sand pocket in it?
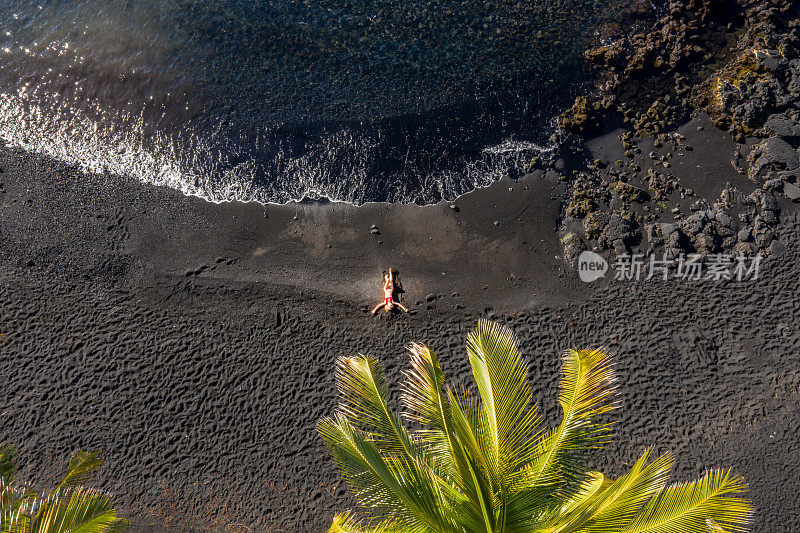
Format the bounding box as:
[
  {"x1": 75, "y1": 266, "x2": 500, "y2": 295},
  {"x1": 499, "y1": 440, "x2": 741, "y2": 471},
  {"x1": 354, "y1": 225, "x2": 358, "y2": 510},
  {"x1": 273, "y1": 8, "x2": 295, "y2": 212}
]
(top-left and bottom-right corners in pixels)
[{"x1": 559, "y1": 0, "x2": 800, "y2": 138}]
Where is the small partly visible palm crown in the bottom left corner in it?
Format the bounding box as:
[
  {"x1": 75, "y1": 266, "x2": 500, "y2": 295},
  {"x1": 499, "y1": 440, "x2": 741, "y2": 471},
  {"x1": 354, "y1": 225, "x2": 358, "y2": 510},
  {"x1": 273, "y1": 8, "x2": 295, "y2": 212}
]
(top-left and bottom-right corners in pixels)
[{"x1": 0, "y1": 444, "x2": 129, "y2": 533}]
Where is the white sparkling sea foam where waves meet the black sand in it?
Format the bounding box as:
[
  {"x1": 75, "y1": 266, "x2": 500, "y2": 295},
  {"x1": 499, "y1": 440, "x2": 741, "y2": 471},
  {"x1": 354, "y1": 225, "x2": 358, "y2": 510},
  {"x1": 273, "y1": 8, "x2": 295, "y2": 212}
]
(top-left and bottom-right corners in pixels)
[{"x1": 0, "y1": 86, "x2": 553, "y2": 203}]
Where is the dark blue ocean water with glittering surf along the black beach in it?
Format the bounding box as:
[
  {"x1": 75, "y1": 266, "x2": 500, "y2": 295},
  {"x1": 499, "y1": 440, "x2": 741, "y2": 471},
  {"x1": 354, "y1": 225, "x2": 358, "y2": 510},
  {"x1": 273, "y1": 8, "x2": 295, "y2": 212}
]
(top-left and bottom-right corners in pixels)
[{"x1": 0, "y1": 0, "x2": 628, "y2": 203}]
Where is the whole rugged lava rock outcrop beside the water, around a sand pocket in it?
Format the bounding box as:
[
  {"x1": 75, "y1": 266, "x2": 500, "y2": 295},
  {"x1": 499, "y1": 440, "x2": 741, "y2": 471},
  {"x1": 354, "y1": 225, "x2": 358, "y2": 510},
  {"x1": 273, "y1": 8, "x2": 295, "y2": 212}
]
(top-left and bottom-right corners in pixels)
[{"x1": 559, "y1": 0, "x2": 800, "y2": 266}]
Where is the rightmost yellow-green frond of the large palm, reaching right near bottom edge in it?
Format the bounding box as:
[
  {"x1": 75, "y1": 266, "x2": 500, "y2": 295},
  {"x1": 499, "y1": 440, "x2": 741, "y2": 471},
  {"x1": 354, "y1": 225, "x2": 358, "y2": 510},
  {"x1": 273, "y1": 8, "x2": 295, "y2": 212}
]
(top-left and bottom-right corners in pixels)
[{"x1": 622, "y1": 470, "x2": 753, "y2": 533}]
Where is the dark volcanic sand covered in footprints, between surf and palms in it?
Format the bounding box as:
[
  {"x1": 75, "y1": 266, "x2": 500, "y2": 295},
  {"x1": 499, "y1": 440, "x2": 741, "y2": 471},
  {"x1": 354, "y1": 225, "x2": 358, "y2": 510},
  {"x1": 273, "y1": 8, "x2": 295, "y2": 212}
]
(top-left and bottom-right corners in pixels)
[{"x1": 0, "y1": 114, "x2": 800, "y2": 533}]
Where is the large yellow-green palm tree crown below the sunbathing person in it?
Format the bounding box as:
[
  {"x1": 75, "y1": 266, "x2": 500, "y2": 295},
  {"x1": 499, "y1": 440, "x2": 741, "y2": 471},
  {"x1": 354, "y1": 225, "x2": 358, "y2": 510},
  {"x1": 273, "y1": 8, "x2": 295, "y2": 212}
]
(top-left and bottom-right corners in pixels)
[{"x1": 318, "y1": 321, "x2": 752, "y2": 533}]
